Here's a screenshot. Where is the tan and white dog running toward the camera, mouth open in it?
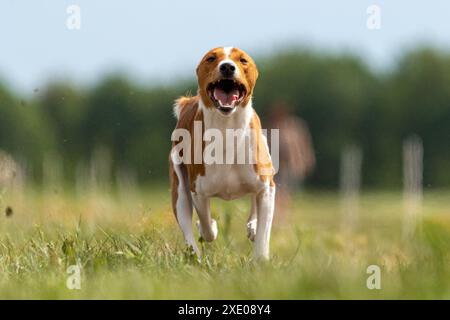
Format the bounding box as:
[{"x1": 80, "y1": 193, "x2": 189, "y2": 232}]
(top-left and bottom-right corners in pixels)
[{"x1": 169, "y1": 47, "x2": 275, "y2": 259}]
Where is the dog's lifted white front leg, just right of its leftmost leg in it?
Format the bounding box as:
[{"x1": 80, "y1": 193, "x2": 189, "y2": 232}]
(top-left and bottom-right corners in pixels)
[{"x1": 192, "y1": 194, "x2": 218, "y2": 242}]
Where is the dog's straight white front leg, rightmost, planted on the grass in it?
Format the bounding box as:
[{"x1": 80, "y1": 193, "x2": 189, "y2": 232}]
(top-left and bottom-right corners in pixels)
[{"x1": 254, "y1": 184, "x2": 275, "y2": 260}]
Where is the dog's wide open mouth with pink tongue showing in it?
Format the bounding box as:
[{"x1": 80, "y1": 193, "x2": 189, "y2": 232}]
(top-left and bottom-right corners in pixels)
[{"x1": 208, "y1": 79, "x2": 246, "y2": 115}]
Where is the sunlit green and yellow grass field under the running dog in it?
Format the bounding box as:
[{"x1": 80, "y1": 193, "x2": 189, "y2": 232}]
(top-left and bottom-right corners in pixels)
[{"x1": 0, "y1": 188, "x2": 450, "y2": 299}]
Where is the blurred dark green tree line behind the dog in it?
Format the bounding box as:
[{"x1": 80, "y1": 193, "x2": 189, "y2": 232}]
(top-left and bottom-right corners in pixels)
[{"x1": 0, "y1": 48, "x2": 450, "y2": 187}]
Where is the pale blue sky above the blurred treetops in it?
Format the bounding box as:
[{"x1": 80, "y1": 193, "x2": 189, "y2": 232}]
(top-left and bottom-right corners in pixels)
[{"x1": 0, "y1": 0, "x2": 450, "y2": 93}]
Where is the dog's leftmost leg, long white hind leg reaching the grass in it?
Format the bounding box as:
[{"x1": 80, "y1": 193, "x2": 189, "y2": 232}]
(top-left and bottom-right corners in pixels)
[{"x1": 170, "y1": 152, "x2": 201, "y2": 258}]
